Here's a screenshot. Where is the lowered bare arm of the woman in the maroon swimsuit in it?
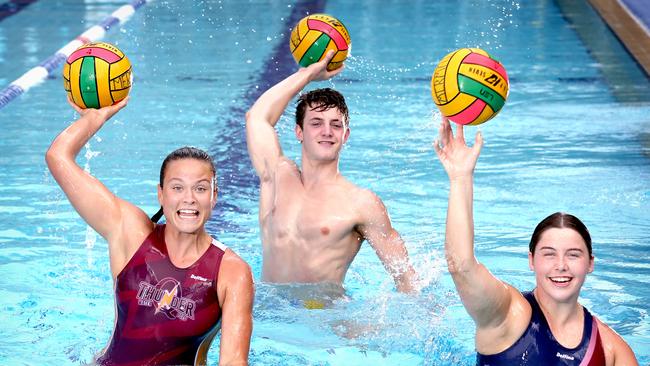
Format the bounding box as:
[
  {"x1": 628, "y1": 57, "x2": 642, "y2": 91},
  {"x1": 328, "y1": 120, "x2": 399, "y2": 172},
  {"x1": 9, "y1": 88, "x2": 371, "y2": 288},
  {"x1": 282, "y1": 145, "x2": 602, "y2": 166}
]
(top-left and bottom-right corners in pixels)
[{"x1": 217, "y1": 251, "x2": 254, "y2": 366}]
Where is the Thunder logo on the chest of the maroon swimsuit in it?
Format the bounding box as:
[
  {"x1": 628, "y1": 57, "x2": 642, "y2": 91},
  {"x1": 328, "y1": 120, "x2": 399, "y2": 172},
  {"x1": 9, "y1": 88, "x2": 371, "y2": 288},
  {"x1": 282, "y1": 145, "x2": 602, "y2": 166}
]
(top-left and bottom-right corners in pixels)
[{"x1": 136, "y1": 277, "x2": 196, "y2": 321}]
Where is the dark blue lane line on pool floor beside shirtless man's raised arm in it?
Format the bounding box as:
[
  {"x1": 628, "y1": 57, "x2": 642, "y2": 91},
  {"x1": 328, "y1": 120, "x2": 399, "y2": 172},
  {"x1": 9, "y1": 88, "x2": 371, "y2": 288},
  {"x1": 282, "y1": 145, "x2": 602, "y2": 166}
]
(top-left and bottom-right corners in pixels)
[{"x1": 206, "y1": 0, "x2": 326, "y2": 233}]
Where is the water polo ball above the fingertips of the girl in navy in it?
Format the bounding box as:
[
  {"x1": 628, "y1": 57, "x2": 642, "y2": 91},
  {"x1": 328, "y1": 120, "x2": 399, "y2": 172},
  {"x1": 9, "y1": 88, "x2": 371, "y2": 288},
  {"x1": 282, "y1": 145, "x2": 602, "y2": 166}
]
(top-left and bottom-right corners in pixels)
[{"x1": 431, "y1": 48, "x2": 510, "y2": 125}]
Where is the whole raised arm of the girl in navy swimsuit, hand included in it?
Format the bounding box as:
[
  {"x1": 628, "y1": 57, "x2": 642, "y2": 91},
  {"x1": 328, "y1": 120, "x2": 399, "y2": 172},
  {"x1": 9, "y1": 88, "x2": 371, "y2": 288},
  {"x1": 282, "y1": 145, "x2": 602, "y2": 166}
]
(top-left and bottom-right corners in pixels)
[{"x1": 434, "y1": 118, "x2": 525, "y2": 328}]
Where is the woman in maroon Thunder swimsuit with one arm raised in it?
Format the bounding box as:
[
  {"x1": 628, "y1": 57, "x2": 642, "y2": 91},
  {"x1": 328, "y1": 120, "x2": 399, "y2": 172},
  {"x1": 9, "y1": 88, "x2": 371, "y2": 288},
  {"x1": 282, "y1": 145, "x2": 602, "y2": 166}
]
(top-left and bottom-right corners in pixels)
[{"x1": 46, "y1": 100, "x2": 253, "y2": 365}]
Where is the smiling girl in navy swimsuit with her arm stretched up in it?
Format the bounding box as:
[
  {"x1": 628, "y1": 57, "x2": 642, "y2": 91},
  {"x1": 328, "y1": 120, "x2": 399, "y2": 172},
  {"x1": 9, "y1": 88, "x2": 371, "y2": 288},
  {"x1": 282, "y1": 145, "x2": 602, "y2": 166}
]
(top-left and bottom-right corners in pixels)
[{"x1": 434, "y1": 118, "x2": 637, "y2": 366}]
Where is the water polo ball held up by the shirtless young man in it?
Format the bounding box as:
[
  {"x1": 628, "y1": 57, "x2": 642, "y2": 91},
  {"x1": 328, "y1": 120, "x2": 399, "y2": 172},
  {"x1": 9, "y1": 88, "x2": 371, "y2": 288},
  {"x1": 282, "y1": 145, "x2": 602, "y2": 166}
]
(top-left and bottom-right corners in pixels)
[{"x1": 289, "y1": 14, "x2": 350, "y2": 71}]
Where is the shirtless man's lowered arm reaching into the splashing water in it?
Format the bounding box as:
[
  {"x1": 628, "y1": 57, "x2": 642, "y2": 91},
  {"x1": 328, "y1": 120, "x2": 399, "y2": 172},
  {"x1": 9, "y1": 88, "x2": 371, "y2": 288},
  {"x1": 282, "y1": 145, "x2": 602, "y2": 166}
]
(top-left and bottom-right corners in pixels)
[{"x1": 359, "y1": 191, "x2": 418, "y2": 293}]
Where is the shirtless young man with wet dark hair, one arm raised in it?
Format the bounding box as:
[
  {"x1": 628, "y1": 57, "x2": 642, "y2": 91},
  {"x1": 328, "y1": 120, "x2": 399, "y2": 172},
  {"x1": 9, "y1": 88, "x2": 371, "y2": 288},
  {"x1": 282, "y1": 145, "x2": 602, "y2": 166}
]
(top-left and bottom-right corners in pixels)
[{"x1": 246, "y1": 52, "x2": 416, "y2": 292}]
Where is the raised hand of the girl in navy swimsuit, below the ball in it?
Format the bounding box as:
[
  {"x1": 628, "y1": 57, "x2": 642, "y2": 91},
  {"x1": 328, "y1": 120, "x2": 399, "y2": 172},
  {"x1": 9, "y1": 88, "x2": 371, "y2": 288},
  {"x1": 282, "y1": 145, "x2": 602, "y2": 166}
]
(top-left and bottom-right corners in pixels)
[{"x1": 433, "y1": 117, "x2": 483, "y2": 180}]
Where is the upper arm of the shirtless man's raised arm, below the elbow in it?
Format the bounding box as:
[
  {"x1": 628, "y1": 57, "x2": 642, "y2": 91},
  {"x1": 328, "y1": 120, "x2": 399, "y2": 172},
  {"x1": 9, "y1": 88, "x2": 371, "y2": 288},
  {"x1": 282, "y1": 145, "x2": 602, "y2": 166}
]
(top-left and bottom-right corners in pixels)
[{"x1": 246, "y1": 119, "x2": 282, "y2": 178}]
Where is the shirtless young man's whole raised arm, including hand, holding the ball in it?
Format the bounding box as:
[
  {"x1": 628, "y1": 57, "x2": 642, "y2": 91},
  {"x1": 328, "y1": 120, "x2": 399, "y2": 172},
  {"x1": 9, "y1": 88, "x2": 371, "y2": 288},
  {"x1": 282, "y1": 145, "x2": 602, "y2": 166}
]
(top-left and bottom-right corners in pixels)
[{"x1": 246, "y1": 51, "x2": 343, "y2": 178}]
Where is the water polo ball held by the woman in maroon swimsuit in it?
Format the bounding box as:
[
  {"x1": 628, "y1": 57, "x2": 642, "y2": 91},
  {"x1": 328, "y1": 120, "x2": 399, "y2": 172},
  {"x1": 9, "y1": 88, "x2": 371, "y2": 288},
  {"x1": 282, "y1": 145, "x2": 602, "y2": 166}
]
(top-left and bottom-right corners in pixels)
[{"x1": 63, "y1": 42, "x2": 131, "y2": 109}]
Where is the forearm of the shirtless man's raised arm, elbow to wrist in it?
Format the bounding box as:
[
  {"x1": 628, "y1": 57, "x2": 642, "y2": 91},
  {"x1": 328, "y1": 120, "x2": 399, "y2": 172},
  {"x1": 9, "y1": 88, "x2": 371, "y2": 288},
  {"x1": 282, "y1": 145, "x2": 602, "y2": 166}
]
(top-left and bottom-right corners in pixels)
[{"x1": 247, "y1": 68, "x2": 313, "y2": 126}]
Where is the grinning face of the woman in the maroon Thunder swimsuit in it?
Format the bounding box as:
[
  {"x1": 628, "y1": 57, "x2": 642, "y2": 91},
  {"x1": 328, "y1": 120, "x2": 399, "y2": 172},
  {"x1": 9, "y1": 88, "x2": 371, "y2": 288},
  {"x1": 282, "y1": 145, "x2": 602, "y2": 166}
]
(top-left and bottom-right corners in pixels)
[{"x1": 158, "y1": 158, "x2": 217, "y2": 234}]
